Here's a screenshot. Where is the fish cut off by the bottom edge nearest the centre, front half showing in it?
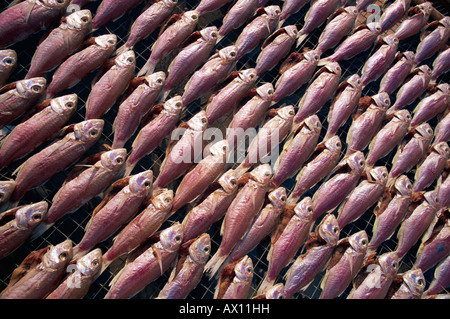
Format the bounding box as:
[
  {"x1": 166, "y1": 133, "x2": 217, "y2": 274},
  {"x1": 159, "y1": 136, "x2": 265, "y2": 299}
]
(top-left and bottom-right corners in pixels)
[{"x1": 214, "y1": 256, "x2": 254, "y2": 299}]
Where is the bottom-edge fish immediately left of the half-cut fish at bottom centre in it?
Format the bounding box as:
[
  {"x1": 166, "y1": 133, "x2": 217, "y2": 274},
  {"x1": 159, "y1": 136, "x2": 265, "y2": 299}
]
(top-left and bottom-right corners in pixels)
[{"x1": 157, "y1": 234, "x2": 211, "y2": 299}]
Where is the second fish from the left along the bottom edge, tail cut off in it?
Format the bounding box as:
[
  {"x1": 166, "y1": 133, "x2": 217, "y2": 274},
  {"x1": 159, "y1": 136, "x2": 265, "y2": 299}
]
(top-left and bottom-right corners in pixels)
[{"x1": 45, "y1": 248, "x2": 102, "y2": 299}]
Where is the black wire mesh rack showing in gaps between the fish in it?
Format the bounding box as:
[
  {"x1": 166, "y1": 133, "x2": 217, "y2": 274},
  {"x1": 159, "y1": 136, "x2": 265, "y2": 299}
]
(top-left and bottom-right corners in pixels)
[{"x1": 0, "y1": 0, "x2": 448, "y2": 299}]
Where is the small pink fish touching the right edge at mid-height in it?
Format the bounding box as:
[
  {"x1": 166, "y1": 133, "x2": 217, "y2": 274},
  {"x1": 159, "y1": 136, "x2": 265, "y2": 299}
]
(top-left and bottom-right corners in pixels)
[{"x1": 413, "y1": 142, "x2": 450, "y2": 192}]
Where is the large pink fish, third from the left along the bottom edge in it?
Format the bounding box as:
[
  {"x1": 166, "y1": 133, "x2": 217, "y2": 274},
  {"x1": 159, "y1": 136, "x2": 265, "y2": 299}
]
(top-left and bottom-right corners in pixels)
[{"x1": 105, "y1": 222, "x2": 183, "y2": 299}]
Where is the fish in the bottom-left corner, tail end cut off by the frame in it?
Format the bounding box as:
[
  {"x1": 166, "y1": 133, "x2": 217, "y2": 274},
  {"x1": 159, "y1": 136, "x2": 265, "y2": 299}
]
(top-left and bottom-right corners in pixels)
[{"x1": 0, "y1": 239, "x2": 72, "y2": 299}]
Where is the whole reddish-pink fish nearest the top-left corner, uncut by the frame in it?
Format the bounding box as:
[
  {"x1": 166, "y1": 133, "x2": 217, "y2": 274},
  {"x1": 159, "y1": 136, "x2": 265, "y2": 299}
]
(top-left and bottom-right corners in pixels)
[{"x1": 26, "y1": 10, "x2": 92, "y2": 79}]
